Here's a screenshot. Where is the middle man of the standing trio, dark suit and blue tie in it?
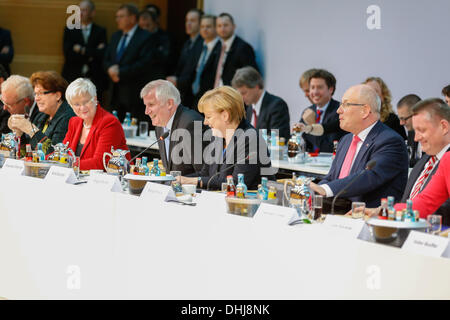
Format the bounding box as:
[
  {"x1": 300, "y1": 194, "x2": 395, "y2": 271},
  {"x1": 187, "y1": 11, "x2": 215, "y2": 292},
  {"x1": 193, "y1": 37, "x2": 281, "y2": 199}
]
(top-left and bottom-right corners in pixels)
[{"x1": 177, "y1": 15, "x2": 221, "y2": 110}]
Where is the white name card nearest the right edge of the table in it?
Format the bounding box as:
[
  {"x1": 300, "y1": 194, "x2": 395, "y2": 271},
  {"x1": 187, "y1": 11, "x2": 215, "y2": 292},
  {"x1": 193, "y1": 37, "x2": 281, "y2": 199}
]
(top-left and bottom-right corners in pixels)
[{"x1": 402, "y1": 231, "x2": 449, "y2": 257}]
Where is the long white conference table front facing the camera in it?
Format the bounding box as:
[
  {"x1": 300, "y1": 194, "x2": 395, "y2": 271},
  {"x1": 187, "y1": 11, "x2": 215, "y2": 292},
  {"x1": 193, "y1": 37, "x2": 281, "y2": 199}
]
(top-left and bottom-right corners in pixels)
[{"x1": 0, "y1": 172, "x2": 450, "y2": 299}]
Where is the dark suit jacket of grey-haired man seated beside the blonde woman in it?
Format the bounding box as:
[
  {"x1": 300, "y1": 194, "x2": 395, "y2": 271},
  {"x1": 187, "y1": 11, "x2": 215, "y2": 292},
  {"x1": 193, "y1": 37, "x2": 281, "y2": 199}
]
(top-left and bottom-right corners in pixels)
[{"x1": 155, "y1": 105, "x2": 205, "y2": 176}]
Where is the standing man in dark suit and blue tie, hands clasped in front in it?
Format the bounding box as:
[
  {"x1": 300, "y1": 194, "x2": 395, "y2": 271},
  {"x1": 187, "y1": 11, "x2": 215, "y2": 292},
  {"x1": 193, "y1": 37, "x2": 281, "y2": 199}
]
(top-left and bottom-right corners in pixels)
[{"x1": 103, "y1": 4, "x2": 153, "y2": 120}]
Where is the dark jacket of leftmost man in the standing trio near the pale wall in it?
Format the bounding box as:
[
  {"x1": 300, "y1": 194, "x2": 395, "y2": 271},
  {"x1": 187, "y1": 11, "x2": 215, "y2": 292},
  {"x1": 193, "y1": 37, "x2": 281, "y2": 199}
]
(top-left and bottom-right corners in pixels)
[{"x1": 175, "y1": 35, "x2": 204, "y2": 109}]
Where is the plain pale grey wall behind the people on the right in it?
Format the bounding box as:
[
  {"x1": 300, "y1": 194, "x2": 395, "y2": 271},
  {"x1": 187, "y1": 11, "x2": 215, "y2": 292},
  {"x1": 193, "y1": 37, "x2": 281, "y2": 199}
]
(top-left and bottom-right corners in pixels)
[{"x1": 205, "y1": 0, "x2": 450, "y2": 124}]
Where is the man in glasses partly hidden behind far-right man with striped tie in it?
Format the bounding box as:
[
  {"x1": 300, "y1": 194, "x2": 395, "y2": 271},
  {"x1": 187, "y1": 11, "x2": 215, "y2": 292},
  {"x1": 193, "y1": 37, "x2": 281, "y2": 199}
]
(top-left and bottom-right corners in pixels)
[{"x1": 397, "y1": 94, "x2": 422, "y2": 168}]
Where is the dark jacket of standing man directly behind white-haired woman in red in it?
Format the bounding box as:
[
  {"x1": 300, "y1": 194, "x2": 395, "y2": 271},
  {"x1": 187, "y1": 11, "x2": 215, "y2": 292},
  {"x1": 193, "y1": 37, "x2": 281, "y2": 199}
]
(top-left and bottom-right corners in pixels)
[{"x1": 62, "y1": 23, "x2": 108, "y2": 94}]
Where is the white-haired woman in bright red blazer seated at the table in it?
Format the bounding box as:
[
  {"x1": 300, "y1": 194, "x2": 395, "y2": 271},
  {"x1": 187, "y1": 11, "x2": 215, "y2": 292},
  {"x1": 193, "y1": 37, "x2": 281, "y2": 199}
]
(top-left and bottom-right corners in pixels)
[{"x1": 63, "y1": 78, "x2": 130, "y2": 170}]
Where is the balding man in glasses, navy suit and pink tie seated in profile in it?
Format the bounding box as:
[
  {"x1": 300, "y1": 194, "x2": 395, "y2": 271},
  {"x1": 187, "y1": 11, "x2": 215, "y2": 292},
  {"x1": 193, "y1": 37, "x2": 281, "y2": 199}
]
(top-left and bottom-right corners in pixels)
[{"x1": 311, "y1": 85, "x2": 408, "y2": 213}]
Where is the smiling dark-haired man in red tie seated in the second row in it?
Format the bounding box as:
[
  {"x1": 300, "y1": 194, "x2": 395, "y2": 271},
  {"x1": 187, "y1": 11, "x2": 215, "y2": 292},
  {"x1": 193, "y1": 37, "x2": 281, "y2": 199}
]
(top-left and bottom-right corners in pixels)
[{"x1": 294, "y1": 69, "x2": 345, "y2": 152}]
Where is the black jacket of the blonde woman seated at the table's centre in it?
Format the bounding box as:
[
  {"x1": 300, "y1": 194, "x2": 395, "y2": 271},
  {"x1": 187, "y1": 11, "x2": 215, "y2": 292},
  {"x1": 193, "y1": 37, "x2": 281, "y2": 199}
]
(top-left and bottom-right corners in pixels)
[{"x1": 194, "y1": 119, "x2": 274, "y2": 190}]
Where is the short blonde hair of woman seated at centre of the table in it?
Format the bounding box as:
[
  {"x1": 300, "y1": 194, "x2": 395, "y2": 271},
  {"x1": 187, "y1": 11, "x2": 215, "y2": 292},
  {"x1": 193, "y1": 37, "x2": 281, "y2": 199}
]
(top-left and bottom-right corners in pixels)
[{"x1": 198, "y1": 86, "x2": 245, "y2": 123}]
